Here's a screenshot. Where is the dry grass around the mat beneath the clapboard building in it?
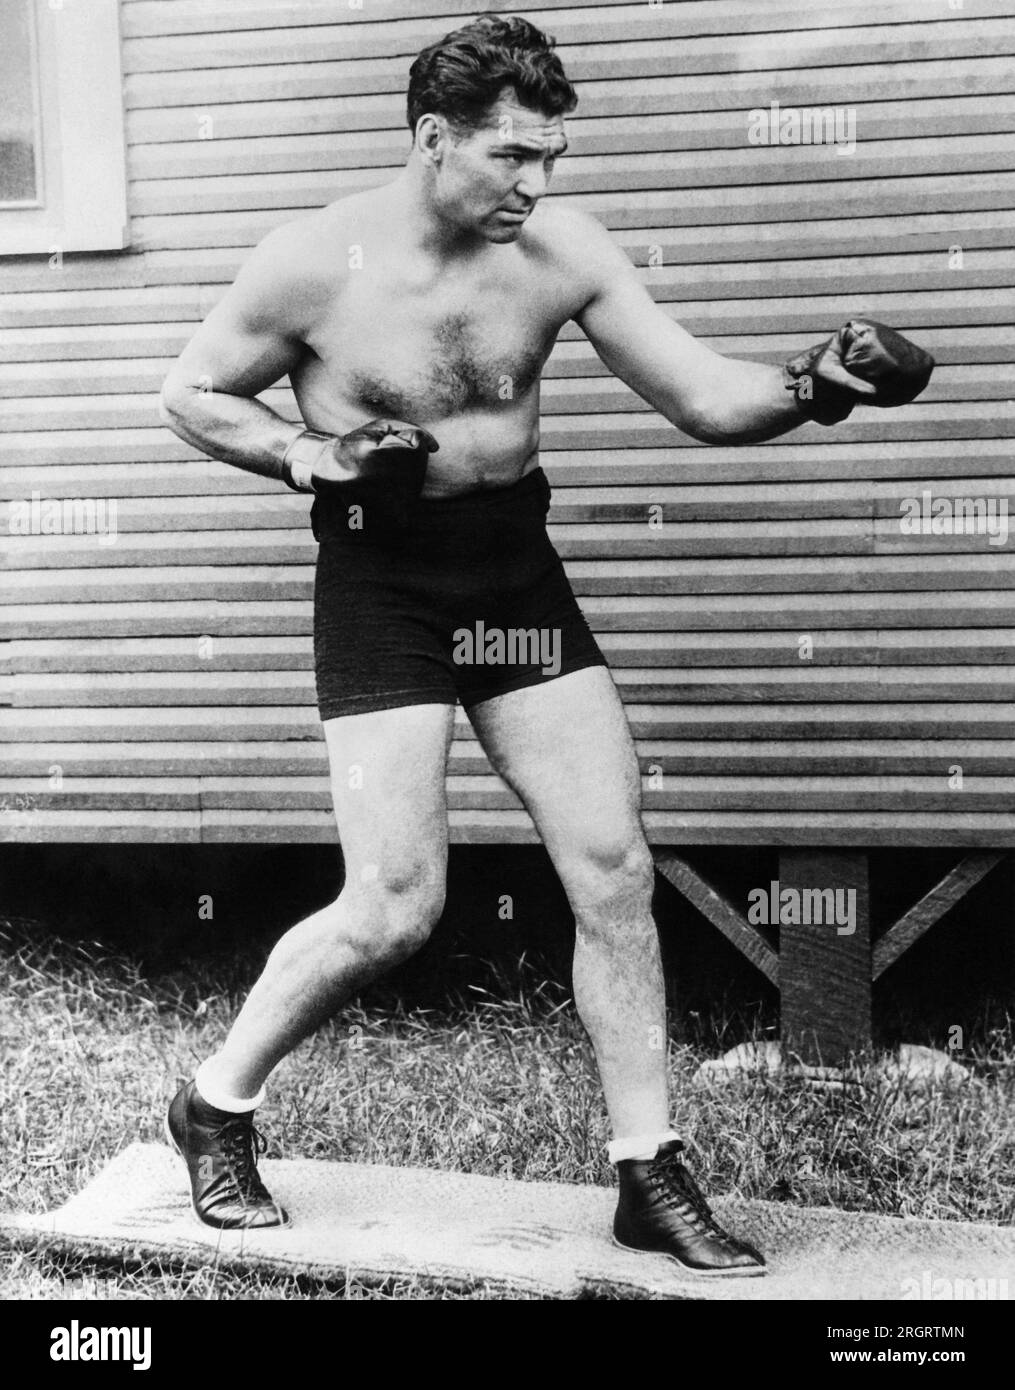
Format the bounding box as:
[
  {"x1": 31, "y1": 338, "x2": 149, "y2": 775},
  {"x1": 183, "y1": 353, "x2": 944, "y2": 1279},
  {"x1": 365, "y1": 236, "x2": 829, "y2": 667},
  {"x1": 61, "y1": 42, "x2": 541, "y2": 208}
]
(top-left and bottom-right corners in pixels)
[{"x1": 0, "y1": 924, "x2": 1015, "y2": 1300}]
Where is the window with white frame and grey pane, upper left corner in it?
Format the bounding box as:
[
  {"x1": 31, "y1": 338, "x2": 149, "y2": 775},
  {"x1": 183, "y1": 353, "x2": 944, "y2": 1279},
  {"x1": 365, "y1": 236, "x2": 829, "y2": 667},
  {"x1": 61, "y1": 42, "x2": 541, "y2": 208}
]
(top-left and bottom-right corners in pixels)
[{"x1": 0, "y1": 0, "x2": 127, "y2": 256}]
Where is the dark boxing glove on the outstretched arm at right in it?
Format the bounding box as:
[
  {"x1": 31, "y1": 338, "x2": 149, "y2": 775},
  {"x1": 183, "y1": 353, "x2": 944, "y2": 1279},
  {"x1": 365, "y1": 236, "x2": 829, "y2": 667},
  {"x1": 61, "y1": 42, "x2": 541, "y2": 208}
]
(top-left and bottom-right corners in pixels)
[{"x1": 783, "y1": 318, "x2": 934, "y2": 425}]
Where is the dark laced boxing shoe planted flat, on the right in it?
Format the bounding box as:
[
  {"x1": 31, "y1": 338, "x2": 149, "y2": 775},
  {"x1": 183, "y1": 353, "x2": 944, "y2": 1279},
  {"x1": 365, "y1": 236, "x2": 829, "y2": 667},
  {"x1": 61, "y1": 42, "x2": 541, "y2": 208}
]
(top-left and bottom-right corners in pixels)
[{"x1": 613, "y1": 1140, "x2": 768, "y2": 1276}]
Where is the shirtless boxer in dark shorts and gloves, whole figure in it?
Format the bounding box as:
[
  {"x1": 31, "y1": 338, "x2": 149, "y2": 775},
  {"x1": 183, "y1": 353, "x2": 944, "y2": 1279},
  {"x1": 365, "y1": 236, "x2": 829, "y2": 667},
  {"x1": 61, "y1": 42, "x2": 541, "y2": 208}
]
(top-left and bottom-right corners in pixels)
[{"x1": 163, "y1": 15, "x2": 933, "y2": 1275}]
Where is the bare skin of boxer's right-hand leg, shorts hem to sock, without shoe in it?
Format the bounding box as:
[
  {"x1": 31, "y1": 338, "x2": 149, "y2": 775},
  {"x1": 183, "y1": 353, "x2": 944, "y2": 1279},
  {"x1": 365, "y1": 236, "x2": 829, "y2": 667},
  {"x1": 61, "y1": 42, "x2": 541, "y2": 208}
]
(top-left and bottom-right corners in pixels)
[{"x1": 470, "y1": 666, "x2": 669, "y2": 1137}]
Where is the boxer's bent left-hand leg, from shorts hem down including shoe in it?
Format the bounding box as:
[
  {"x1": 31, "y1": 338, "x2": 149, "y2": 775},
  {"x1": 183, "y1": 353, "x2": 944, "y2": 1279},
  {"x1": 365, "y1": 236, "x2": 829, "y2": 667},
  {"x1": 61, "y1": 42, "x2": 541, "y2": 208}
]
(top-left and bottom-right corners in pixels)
[{"x1": 168, "y1": 705, "x2": 453, "y2": 1226}]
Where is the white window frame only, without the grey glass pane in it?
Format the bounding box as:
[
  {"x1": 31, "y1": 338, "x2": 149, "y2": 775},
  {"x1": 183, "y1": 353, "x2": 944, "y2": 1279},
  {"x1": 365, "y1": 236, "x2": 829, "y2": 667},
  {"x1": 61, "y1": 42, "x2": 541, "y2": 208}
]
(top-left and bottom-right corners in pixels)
[{"x1": 0, "y1": 0, "x2": 129, "y2": 256}]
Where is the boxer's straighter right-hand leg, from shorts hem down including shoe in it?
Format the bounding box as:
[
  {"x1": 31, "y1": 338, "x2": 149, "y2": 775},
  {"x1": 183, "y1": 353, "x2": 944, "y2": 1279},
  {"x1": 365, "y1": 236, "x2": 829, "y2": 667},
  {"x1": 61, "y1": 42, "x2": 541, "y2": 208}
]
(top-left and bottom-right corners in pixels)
[{"x1": 470, "y1": 666, "x2": 765, "y2": 1276}]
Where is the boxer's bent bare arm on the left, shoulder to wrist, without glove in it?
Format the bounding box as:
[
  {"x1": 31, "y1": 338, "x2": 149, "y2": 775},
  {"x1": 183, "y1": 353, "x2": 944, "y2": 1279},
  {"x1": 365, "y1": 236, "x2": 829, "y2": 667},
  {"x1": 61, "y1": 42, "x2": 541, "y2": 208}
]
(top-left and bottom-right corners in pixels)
[{"x1": 161, "y1": 225, "x2": 316, "y2": 478}]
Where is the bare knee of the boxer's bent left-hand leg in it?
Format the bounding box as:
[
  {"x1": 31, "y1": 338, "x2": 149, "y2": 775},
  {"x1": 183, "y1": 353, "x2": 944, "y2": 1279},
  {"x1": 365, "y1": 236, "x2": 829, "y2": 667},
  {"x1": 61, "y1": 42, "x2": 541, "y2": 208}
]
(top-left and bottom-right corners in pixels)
[{"x1": 332, "y1": 860, "x2": 445, "y2": 965}]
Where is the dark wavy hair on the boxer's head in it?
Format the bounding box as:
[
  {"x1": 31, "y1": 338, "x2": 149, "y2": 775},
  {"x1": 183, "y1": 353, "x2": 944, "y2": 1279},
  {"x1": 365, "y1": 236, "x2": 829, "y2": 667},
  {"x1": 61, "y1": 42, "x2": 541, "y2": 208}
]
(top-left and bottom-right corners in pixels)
[{"x1": 407, "y1": 14, "x2": 578, "y2": 132}]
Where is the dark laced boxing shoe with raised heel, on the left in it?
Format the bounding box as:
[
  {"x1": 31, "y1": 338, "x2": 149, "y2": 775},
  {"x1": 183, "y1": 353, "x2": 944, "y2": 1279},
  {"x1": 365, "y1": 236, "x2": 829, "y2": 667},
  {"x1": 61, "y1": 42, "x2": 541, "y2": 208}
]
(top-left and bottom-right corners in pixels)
[{"x1": 165, "y1": 1081, "x2": 289, "y2": 1230}]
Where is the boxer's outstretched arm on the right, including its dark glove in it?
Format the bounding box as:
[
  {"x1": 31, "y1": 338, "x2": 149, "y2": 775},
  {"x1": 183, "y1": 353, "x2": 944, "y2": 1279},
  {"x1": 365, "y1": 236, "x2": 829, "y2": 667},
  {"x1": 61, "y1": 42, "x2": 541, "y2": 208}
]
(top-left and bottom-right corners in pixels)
[{"x1": 566, "y1": 210, "x2": 934, "y2": 443}]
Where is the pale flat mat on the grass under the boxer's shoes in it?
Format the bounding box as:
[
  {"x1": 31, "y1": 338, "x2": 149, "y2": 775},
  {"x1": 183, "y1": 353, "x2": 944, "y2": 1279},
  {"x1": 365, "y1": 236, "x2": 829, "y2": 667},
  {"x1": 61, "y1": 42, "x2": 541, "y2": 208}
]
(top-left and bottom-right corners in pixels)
[{"x1": 0, "y1": 1144, "x2": 1015, "y2": 1300}]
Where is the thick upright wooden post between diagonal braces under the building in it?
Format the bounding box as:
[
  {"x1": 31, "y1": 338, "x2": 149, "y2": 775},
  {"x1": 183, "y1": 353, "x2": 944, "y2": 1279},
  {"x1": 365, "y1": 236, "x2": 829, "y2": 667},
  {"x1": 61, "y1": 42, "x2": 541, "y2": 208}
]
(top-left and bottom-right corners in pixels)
[{"x1": 779, "y1": 849, "x2": 870, "y2": 1066}]
